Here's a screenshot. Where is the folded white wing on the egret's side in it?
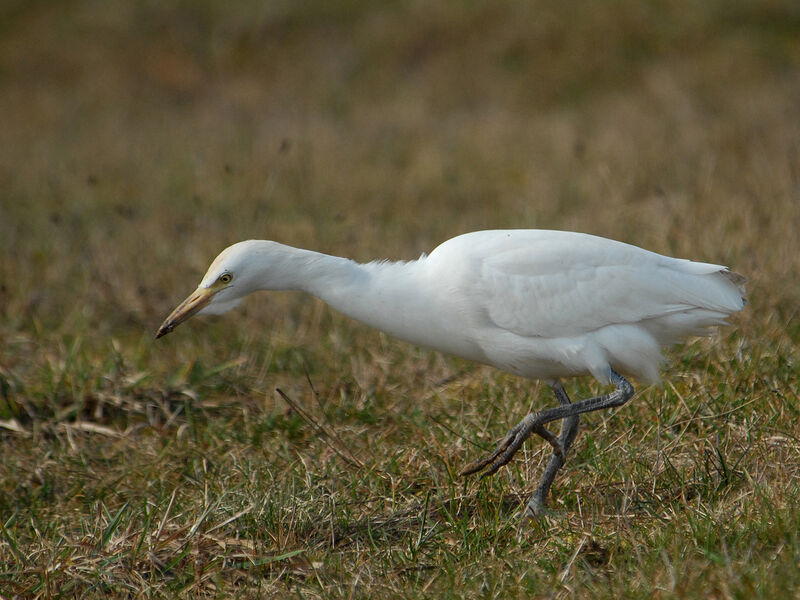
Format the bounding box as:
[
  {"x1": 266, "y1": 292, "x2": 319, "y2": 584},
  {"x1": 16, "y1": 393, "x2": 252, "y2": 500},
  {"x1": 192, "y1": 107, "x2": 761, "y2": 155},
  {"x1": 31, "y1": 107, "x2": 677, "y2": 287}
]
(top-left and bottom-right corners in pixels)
[{"x1": 477, "y1": 236, "x2": 721, "y2": 337}]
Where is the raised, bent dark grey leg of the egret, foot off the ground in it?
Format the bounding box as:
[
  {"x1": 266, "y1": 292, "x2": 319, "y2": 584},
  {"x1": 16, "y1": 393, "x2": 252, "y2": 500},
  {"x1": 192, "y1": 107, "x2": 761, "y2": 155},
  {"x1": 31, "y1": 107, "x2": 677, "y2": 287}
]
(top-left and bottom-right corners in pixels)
[{"x1": 461, "y1": 369, "x2": 633, "y2": 488}]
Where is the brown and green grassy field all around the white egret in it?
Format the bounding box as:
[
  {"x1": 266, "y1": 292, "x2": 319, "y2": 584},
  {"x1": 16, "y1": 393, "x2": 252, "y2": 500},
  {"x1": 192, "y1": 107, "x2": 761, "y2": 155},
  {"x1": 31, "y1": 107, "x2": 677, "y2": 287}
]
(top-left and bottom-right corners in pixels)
[{"x1": 0, "y1": 0, "x2": 800, "y2": 600}]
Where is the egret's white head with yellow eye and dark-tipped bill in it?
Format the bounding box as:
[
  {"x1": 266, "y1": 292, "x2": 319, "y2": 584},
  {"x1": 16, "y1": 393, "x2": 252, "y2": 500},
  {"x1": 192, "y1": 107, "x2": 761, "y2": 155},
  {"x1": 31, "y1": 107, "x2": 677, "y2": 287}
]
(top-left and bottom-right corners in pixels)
[{"x1": 156, "y1": 240, "x2": 266, "y2": 339}]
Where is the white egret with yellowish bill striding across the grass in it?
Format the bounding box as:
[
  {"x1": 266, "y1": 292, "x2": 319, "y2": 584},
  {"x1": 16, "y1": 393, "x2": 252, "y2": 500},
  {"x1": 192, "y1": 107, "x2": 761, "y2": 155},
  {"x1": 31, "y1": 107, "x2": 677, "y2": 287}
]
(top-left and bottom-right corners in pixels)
[{"x1": 156, "y1": 229, "x2": 746, "y2": 515}]
